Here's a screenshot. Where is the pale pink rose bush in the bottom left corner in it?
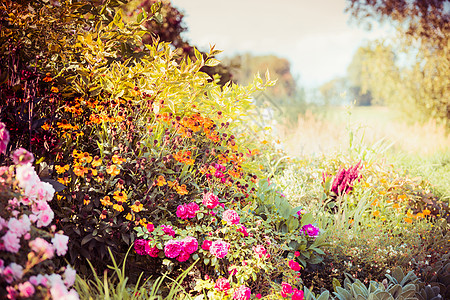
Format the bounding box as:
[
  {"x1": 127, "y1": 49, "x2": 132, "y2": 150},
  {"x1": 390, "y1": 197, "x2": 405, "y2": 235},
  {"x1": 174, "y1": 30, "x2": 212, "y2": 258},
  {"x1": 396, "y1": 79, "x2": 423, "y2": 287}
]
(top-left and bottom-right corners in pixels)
[{"x1": 0, "y1": 122, "x2": 78, "y2": 299}]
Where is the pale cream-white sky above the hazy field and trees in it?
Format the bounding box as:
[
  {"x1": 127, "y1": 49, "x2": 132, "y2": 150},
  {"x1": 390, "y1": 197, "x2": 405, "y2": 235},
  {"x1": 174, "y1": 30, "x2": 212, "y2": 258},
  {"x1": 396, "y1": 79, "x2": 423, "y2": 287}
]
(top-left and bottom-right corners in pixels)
[{"x1": 172, "y1": 0, "x2": 392, "y2": 87}]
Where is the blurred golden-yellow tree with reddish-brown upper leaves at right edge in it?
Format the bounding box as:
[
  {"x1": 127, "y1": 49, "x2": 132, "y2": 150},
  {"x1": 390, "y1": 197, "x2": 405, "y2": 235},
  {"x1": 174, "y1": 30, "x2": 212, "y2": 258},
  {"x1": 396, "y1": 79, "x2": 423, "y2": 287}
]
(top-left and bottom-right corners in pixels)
[{"x1": 347, "y1": 0, "x2": 450, "y2": 129}]
